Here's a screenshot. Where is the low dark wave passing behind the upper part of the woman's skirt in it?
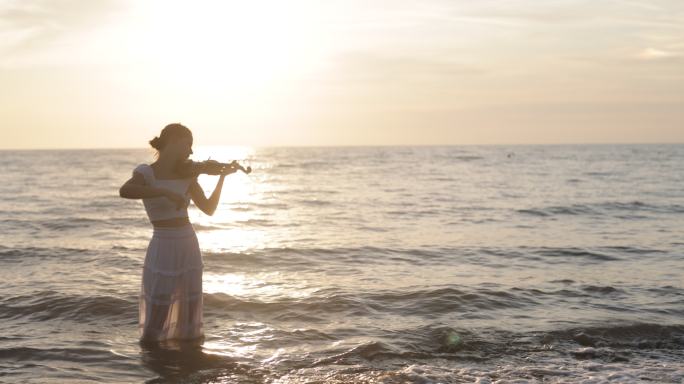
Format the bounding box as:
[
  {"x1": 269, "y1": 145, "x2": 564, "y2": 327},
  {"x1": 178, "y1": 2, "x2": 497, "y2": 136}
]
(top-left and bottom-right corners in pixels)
[{"x1": 0, "y1": 244, "x2": 669, "y2": 268}]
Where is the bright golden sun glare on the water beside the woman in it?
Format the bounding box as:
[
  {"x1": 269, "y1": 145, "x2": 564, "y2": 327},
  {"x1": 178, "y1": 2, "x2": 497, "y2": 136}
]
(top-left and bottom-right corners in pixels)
[{"x1": 189, "y1": 146, "x2": 311, "y2": 308}]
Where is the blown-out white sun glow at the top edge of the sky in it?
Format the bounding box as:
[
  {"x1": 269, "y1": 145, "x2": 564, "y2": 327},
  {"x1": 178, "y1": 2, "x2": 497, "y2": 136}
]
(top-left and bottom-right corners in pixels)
[{"x1": 127, "y1": 0, "x2": 334, "y2": 97}]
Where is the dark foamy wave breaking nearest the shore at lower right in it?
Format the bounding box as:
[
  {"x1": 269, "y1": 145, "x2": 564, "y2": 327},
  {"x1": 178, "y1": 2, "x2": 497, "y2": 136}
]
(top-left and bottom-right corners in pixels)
[{"x1": 302, "y1": 323, "x2": 684, "y2": 366}]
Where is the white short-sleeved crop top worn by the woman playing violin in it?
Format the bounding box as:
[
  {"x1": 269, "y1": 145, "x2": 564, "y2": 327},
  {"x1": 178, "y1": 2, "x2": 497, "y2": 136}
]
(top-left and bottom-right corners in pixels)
[{"x1": 133, "y1": 164, "x2": 195, "y2": 221}]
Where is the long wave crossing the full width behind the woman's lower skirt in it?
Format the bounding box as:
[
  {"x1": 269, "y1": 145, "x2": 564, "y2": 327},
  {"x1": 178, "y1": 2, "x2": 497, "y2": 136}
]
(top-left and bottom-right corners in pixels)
[{"x1": 0, "y1": 280, "x2": 684, "y2": 330}]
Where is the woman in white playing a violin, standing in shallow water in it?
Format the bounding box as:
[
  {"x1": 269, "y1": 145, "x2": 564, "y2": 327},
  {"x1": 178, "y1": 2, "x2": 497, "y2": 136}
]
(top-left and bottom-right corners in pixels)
[{"x1": 119, "y1": 124, "x2": 236, "y2": 341}]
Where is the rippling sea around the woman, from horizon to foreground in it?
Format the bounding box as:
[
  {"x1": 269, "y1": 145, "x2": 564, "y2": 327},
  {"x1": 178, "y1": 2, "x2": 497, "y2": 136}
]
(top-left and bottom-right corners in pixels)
[{"x1": 0, "y1": 145, "x2": 684, "y2": 384}]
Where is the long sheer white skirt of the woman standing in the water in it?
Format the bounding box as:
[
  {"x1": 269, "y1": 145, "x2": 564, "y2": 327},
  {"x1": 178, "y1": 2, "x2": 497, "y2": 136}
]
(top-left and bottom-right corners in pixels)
[{"x1": 138, "y1": 224, "x2": 204, "y2": 341}]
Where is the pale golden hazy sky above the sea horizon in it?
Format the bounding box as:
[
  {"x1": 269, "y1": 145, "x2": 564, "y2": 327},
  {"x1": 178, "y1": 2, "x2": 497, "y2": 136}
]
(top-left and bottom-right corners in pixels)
[{"x1": 0, "y1": 0, "x2": 684, "y2": 148}]
